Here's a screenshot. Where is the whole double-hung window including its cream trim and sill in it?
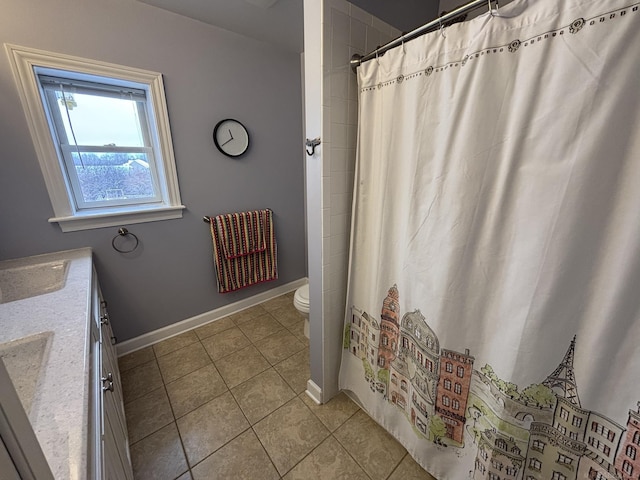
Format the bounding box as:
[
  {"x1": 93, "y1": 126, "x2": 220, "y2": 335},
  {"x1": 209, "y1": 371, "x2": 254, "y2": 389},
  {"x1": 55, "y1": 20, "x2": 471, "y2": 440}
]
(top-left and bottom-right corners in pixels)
[{"x1": 7, "y1": 45, "x2": 185, "y2": 232}]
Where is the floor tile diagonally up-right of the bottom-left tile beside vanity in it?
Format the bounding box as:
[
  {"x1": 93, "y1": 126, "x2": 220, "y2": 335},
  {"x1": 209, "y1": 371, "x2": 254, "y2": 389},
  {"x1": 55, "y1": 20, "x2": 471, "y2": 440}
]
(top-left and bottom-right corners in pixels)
[{"x1": 167, "y1": 364, "x2": 227, "y2": 418}]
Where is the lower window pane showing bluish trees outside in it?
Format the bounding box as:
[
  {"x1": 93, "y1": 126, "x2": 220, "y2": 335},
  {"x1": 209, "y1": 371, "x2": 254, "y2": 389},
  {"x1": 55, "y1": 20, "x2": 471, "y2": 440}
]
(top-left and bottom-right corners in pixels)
[{"x1": 71, "y1": 152, "x2": 157, "y2": 202}]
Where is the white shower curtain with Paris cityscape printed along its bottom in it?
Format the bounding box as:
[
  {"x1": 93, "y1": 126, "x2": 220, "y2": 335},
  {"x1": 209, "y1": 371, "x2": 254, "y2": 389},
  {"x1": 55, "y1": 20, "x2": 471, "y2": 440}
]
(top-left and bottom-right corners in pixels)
[{"x1": 339, "y1": 0, "x2": 640, "y2": 480}]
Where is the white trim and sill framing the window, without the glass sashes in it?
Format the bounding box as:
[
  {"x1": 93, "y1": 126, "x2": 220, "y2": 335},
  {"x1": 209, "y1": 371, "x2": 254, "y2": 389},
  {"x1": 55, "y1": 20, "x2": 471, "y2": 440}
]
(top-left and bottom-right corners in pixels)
[{"x1": 5, "y1": 44, "x2": 186, "y2": 232}]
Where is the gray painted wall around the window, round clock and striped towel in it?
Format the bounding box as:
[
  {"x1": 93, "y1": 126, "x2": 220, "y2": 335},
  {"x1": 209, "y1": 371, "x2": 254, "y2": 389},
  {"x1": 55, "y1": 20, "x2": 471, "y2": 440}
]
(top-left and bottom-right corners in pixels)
[{"x1": 0, "y1": 0, "x2": 306, "y2": 340}]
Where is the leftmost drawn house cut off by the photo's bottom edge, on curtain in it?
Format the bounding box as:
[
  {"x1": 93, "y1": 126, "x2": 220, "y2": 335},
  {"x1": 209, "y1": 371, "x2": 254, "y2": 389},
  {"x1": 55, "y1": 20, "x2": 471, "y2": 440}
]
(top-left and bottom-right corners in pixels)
[{"x1": 473, "y1": 430, "x2": 525, "y2": 480}]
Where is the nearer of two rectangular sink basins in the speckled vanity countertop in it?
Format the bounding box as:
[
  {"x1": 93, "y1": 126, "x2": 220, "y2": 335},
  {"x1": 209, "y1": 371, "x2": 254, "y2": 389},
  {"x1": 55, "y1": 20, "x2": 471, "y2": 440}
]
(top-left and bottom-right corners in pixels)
[{"x1": 0, "y1": 332, "x2": 53, "y2": 414}]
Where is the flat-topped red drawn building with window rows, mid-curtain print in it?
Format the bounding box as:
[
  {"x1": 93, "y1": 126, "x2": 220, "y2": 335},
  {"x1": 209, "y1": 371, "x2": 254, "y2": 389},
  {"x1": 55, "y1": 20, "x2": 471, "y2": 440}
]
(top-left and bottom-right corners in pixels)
[{"x1": 436, "y1": 349, "x2": 475, "y2": 444}]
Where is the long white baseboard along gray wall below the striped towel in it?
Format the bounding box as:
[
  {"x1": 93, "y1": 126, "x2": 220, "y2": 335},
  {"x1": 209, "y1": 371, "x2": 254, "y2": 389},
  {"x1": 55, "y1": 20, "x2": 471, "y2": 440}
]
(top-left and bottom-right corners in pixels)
[{"x1": 116, "y1": 278, "x2": 308, "y2": 357}]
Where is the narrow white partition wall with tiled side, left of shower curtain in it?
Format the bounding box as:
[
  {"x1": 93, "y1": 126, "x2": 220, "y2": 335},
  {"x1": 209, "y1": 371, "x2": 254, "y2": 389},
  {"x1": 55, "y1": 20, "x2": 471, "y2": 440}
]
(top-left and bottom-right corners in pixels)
[{"x1": 305, "y1": 0, "x2": 400, "y2": 401}]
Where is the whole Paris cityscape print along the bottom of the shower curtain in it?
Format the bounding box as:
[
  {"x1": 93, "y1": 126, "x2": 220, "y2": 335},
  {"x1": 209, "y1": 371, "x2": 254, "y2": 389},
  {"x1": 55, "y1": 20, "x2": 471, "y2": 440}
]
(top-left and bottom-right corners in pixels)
[{"x1": 343, "y1": 285, "x2": 640, "y2": 480}]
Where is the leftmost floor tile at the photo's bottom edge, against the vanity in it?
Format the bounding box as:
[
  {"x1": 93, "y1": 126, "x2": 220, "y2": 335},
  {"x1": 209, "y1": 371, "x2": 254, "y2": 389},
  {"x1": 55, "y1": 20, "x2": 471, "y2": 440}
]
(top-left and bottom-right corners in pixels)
[{"x1": 131, "y1": 422, "x2": 188, "y2": 480}]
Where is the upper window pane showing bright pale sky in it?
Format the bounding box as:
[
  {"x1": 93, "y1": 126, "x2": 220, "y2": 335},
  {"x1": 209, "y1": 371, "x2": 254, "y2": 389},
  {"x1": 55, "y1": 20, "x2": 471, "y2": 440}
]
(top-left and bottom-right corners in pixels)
[{"x1": 56, "y1": 90, "x2": 145, "y2": 147}]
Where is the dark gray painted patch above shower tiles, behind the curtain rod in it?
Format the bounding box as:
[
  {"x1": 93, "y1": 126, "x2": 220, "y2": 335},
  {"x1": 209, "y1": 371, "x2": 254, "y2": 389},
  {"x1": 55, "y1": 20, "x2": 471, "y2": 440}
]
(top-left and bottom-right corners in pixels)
[{"x1": 349, "y1": 0, "x2": 438, "y2": 32}]
